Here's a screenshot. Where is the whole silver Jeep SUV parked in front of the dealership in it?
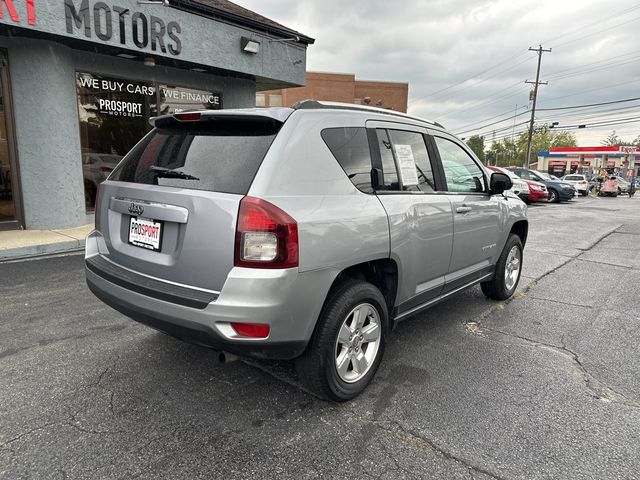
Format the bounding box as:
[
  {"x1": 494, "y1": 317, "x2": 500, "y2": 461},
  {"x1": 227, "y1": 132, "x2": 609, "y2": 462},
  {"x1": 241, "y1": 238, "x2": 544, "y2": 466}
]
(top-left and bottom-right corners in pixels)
[{"x1": 86, "y1": 101, "x2": 528, "y2": 401}]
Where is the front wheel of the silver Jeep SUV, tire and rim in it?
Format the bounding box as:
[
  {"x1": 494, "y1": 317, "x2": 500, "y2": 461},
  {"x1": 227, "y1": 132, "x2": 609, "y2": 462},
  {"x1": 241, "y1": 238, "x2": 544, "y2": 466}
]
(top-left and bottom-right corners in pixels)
[{"x1": 480, "y1": 233, "x2": 522, "y2": 300}]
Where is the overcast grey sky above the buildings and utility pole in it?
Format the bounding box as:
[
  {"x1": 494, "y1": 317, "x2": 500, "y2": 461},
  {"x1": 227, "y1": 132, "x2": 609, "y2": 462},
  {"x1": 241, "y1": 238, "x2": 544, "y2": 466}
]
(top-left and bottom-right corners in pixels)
[{"x1": 236, "y1": 0, "x2": 640, "y2": 145}]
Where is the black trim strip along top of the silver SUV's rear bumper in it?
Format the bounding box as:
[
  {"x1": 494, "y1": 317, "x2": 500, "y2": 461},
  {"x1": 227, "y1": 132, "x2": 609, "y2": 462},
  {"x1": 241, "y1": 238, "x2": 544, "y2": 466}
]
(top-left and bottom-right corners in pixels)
[{"x1": 85, "y1": 255, "x2": 218, "y2": 309}]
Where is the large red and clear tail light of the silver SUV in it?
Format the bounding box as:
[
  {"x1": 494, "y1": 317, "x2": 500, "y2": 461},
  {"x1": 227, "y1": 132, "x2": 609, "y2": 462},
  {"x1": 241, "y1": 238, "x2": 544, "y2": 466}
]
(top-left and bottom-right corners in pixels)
[{"x1": 235, "y1": 197, "x2": 298, "y2": 268}]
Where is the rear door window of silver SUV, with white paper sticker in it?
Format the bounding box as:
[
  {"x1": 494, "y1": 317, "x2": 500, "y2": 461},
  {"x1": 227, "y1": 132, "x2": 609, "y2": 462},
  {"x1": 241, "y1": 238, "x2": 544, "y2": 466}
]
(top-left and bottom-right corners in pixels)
[{"x1": 377, "y1": 129, "x2": 435, "y2": 192}]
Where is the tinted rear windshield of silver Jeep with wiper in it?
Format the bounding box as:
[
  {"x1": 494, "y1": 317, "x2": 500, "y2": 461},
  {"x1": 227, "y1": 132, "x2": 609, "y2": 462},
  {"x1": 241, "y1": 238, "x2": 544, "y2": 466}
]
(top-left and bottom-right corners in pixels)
[{"x1": 109, "y1": 118, "x2": 281, "y2": 195}]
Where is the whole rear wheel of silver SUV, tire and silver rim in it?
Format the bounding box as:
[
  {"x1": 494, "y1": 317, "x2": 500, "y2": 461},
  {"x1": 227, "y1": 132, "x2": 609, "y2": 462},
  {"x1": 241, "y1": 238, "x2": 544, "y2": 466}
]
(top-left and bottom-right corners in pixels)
[{"x1": 296, "y1": 280, "x2": 388, "y2": 402}]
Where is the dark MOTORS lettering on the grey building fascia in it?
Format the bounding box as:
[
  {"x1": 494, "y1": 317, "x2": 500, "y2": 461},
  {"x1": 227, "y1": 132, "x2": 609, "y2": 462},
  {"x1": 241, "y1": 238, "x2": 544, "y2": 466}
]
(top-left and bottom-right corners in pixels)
[{"x1": 64, "y1": 0, "x2": 182, "y2": 56}]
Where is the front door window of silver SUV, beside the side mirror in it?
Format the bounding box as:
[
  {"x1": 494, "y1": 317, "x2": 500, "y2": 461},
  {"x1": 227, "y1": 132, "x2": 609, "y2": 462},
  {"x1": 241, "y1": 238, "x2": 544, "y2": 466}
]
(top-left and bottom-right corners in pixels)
[{"x1": 434, "y1": 137, "x2": 487, "y2": 192}]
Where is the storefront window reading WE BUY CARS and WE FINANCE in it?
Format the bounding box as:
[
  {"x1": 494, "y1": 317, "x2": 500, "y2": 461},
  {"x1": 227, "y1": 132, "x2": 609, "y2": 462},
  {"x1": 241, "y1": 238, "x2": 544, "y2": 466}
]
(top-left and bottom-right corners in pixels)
[{"x1": 76, "y1": 72, "x2": 222, "y2": 212}]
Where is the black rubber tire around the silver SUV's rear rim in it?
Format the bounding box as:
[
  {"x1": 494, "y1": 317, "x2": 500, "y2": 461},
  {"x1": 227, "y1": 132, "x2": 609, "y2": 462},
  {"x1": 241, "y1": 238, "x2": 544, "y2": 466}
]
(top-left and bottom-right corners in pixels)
[{"x1": 296, "y1": 280, "x2": 389, "y2": 402}]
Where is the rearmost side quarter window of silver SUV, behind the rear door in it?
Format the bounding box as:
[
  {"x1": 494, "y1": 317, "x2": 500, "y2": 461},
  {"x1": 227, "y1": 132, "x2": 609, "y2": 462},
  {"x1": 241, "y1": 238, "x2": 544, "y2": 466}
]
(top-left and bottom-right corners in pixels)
[{"x1": 321, "y1": 127, "x2": 373, "y2": 193}]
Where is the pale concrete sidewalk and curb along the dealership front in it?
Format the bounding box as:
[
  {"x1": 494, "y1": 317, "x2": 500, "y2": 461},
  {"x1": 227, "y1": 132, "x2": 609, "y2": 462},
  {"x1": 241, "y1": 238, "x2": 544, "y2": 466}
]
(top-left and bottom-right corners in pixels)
[{"x1": 0, "y1": 223, "x2": 93, "y2": 262}]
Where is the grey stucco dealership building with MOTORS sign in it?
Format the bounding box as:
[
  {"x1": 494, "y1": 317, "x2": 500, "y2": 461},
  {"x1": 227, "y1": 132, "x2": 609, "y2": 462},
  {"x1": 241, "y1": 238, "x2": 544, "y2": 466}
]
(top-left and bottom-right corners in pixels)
[{"x1": 0, "y1": 0, "x2": 313, "y2": 230}]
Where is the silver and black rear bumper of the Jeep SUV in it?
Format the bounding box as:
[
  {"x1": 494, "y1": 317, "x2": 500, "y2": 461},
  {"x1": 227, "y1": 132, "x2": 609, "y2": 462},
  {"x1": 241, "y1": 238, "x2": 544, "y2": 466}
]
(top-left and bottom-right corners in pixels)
[{"x1": 85, "y1": 232, "x2": 336, "y2": 359}]
